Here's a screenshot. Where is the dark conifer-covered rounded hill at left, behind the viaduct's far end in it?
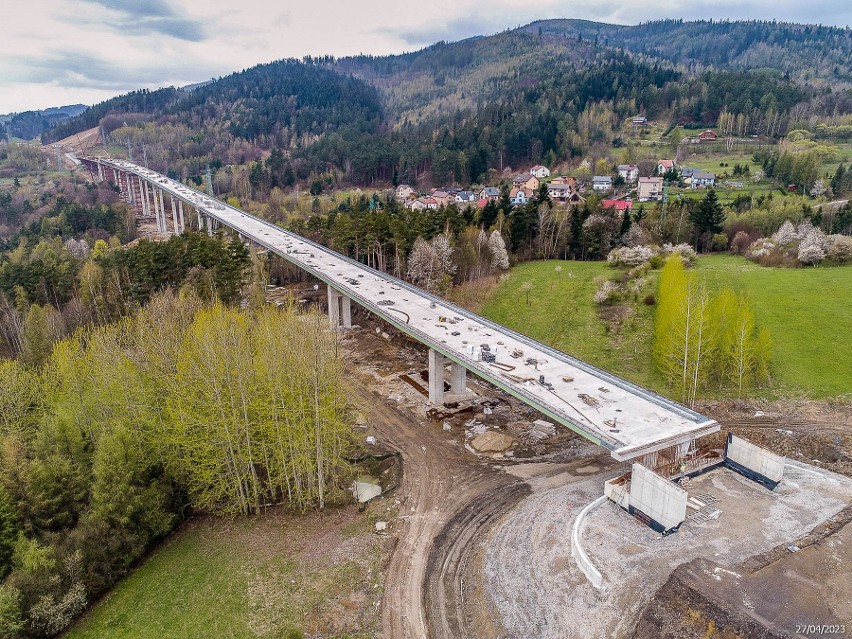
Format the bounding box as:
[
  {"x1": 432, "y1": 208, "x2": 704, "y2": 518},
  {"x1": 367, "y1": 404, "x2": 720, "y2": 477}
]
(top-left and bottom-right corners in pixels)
[{"x1": 42, "y1": 60, "x2": 381, "y2": 147}]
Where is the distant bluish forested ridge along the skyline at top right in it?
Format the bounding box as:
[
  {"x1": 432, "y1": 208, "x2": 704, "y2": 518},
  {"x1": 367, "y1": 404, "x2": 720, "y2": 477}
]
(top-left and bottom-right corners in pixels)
[{"x1": 521, "y1": 20, "x2": 852, "y2": 84}]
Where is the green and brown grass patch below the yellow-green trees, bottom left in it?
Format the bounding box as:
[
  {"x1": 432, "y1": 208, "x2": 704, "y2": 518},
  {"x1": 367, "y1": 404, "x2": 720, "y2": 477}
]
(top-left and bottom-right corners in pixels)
[{"x1": 64, "y1": 506, "x2": 382, "y2": 639}]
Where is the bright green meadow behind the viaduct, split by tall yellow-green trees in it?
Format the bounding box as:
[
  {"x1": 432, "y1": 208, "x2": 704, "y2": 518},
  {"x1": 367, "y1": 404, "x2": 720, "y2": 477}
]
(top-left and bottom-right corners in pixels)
[{"x1": 481, "y1": 255, "x2": 852, "y2": 399}]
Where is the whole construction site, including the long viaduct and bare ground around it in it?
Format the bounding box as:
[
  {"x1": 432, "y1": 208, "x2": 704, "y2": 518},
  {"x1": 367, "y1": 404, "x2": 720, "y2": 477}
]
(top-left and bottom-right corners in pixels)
[{"x1": 83, "y1": 158, "x2": 852, "y2": 639}]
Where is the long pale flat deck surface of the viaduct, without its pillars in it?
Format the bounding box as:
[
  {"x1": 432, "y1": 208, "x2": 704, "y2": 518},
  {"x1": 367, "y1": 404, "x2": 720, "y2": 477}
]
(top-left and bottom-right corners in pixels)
[{"x1": 93, "y1": 158, "x2": 719, "y2": 460}]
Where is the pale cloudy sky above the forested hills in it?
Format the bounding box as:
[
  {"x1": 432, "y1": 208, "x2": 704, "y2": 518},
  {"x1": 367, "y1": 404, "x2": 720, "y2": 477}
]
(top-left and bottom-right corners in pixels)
[{"x1": 0, "y1": 0, "x2": 852, "y2": 113}]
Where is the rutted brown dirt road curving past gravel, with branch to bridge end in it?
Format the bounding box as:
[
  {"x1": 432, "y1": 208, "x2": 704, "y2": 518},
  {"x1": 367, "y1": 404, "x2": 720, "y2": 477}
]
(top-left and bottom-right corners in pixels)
[{"x1": 356, "y1": 368, "x2": 609, "y2": 639}]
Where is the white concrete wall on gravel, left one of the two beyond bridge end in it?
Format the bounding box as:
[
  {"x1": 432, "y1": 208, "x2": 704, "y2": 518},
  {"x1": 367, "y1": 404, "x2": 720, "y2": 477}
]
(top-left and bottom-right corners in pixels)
[{"x1": 629, "y1": 463, "x2": 689, "y2": 534}]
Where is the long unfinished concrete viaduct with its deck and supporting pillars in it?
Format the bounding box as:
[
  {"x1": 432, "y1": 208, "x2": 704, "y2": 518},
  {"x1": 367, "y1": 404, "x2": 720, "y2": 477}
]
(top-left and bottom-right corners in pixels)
[{"x1": 79, "y1": 157, "x2": 719, "y2": 468}]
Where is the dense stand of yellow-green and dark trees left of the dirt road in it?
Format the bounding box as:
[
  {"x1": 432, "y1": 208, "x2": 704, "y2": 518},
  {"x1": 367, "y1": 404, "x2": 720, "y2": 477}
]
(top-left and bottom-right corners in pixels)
[{"x1": 0, "y1": 287, "x2": 352, "y2": 639}]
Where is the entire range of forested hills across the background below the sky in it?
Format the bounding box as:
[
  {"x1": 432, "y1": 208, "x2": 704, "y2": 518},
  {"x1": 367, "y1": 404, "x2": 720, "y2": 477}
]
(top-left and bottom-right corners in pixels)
[{"x1": 36, "y1": 20, "x2": 852, "y2": 188}]
